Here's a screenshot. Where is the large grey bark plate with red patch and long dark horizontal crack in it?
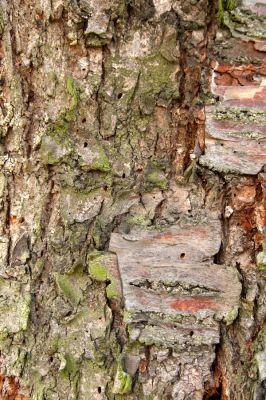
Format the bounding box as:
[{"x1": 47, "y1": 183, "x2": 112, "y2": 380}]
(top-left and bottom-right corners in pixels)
[{"x1": 110, "y1": 216, "x2": 241, "y2": 345}]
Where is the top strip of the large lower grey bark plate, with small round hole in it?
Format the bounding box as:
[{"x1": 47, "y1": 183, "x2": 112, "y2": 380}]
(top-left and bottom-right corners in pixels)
[{"x1": 110, "y1": 217, "x2": 221, "y2": 265}]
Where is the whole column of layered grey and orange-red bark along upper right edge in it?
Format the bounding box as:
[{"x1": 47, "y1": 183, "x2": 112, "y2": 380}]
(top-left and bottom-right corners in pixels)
[{"x1": 200, "y1": 1, "x2": 266, "y2": 175}]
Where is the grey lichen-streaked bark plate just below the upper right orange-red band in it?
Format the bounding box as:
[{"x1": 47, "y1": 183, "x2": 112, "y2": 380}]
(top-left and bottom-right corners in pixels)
[{"x1": 200, "y1": 105, "x2": 266, "y2": 175}]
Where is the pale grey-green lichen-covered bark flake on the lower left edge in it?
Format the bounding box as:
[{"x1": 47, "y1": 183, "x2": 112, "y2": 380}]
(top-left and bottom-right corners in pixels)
[{"x1": 0, "y1": 278, "x2": 31, "y2": 339}]
